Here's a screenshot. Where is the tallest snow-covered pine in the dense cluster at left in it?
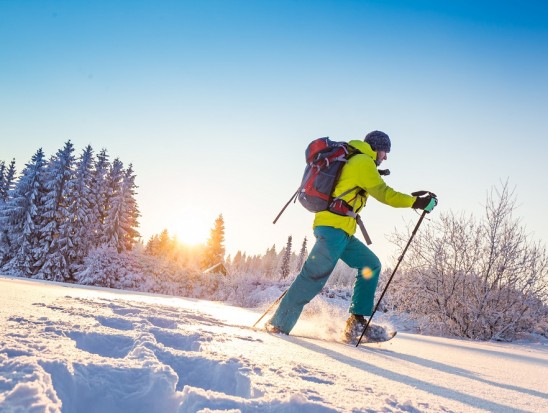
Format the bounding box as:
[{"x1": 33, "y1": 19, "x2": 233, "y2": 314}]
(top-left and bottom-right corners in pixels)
[{"x1": 34, "y1": 140, "x2": 74, "y2": 281}]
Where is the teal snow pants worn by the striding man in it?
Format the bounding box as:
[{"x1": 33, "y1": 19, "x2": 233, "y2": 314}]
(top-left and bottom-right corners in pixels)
[{"x1": 270, "y1": 226, "x2": 381, "y2": 334}]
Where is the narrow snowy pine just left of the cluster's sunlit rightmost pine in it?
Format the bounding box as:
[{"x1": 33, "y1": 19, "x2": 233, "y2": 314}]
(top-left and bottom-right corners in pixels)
[{"x1": 90, "y1": 149, "x2": 110, "y2": 247}]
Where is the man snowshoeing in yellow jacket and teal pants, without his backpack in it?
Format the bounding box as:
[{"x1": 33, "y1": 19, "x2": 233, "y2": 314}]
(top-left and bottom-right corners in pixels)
[{"x1": 266, "y1": 131, "x2": 437, "y2": 342}]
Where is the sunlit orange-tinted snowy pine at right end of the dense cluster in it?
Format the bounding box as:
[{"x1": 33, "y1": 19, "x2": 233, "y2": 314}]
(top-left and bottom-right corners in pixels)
[{"x1": 105, "y1": 159, "x2": 140, "y2": 252}]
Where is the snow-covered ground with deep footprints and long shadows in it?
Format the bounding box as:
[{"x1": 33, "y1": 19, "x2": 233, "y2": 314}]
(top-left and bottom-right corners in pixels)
[{"x1": 0, "y1": 277, "x2": 548, "y2": 413}]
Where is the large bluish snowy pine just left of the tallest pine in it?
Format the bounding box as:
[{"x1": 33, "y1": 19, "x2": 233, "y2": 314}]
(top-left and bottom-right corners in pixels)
[{"x1": 0, "y1": 148, "x2": 46, "y2": 277}]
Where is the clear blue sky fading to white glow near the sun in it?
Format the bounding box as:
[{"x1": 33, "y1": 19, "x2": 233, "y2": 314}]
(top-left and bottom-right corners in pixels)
[{"x1": 0, "y1": 0, "x2": 548, "y2": 266}]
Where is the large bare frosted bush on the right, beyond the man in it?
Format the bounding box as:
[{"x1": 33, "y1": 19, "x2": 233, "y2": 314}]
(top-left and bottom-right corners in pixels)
[{"x1": 387, "y1": 184, "x2": 548, "y2": 340}]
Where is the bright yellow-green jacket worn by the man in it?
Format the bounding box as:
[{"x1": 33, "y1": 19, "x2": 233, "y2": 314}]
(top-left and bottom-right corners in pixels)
[{"x1": 314, "y1": 140, "x2": 416, "y2": 235}]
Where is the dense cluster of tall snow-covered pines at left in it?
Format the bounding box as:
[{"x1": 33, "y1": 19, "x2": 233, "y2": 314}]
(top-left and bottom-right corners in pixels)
[{"x1": 0, "y1": 141, "x2": 140, "y2": 281}]
